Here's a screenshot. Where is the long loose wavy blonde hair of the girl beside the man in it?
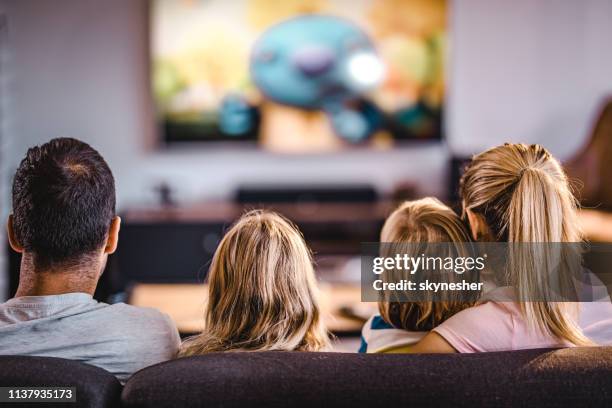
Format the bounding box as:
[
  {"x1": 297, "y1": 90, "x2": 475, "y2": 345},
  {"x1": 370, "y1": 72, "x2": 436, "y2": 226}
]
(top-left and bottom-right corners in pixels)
[{"x1": 179, "y1": 210, "x2": 329, "y2": 356}]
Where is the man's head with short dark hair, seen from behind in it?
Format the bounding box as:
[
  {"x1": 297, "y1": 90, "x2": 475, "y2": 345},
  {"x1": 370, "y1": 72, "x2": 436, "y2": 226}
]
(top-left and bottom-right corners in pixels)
[{"x1": 8, "y1": 138, "x2": 120, "y2": 271}]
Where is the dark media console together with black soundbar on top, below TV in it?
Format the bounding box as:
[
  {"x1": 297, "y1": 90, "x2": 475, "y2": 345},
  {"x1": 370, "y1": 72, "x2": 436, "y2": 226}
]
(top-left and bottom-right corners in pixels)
[{"x1": 112, "y1": 186, "x2": 391, "y2": 283}]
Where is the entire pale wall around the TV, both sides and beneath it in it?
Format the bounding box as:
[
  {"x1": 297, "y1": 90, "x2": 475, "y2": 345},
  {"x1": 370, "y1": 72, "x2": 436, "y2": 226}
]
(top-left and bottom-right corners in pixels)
[{"x1": 0, "y1": 0, "x2": 612, "y2": 296}]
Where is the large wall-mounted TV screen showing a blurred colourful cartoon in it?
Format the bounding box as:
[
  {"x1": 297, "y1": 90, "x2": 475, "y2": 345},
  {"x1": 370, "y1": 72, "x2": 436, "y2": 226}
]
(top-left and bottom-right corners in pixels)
[{"x1": 150, "y1": 0, "x2": 447, "y2": 153}]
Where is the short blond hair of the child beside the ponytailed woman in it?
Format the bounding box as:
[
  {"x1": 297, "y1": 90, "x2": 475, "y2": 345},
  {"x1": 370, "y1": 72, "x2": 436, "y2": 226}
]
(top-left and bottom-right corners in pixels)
[{"x1": 378, "y1": 198, "x2": 480, "y2": 331}]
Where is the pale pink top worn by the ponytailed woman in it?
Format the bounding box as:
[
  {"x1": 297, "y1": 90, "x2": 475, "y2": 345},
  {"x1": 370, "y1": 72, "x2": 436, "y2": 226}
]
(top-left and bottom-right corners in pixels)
[{"x1": 433, "y1": 288, "x2": 612, "y2": 353}]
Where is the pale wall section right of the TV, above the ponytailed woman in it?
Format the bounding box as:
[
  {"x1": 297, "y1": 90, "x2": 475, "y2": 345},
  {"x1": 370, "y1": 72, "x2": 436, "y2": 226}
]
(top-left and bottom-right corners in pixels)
[{"x1": 448, "y1": 0, "x2": 612, "y2": 159}]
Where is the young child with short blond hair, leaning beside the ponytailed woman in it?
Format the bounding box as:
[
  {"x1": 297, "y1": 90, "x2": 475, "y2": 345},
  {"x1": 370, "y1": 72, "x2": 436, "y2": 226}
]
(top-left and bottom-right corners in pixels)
[{"x1": 359, "y1": 198, "x2": 480, "y2": 353}]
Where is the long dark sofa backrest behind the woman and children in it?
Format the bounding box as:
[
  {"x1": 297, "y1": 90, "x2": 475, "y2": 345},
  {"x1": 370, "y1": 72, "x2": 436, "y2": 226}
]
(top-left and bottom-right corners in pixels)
[{"x1": 123, "y1": 347, "x2": 612, "y2": 408}]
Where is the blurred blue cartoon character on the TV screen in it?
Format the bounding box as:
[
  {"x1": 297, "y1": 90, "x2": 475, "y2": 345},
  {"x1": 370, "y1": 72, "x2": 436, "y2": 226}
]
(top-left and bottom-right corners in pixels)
[{"x1": 250, "y1": 14, "x2": 384, "y2": 142}]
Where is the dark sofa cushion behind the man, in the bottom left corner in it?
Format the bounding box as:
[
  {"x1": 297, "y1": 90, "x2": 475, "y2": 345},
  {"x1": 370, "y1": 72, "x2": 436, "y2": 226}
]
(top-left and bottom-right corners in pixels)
[{"x1": 0, "y1": 356, "x2": 121, "y2": 408}]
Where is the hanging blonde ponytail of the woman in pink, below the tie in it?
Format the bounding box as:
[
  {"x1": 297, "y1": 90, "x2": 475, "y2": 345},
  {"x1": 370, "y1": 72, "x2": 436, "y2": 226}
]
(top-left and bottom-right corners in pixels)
[{"x1": 508, "y1": 167, "x2": 592, "y2": 345}]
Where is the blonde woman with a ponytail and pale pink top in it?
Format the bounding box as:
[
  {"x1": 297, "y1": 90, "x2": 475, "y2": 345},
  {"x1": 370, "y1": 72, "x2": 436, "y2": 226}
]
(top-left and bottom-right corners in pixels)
[{"x1": 409, "y1": 144, "x2": 612, "y2": 353}]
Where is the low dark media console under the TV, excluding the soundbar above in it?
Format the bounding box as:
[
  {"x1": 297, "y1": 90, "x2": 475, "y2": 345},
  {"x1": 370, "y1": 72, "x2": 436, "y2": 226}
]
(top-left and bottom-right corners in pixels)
[{"x1": 114, "y1": 204, "x2": 385, "y2": 283}]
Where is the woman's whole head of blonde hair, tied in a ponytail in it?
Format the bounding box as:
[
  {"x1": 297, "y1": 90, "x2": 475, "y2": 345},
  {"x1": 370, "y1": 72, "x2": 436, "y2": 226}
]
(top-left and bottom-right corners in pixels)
[{"x1": 460, "y1": 144, "x2": 592, "y2": 345}]
